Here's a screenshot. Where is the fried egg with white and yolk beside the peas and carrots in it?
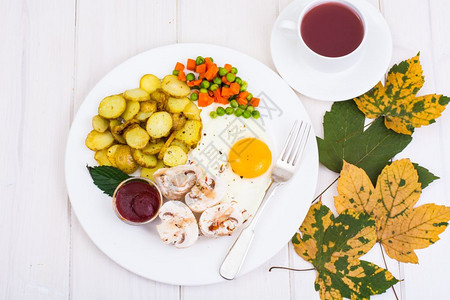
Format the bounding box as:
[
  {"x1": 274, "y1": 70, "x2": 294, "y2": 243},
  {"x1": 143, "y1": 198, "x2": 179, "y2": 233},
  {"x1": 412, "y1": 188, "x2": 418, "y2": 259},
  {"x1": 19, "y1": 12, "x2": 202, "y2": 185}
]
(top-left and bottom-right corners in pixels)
[{"x1": 189, "y1": 104, "x2": 272, "y2": 215}]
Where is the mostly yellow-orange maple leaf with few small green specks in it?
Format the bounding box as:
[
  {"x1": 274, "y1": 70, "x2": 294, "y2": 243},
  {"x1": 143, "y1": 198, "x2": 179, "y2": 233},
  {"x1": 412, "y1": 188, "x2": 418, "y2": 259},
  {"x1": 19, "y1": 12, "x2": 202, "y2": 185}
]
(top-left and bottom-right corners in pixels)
[{"x1": 334, "y1": 159, "x2": 450, "y2": 263}]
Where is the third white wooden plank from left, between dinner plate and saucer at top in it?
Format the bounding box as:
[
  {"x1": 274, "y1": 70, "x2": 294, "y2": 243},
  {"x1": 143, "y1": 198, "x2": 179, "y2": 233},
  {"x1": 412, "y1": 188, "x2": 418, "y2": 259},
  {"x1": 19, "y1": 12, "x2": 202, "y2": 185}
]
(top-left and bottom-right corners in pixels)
[{"x1": 178, "y1": 0, "x2": 289, "y2": 300}]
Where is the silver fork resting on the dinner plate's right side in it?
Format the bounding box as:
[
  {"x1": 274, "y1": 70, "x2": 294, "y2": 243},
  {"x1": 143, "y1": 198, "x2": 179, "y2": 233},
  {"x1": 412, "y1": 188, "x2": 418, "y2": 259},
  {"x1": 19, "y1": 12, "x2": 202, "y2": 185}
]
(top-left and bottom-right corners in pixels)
[{"x1": 219, "y1": 121, "x2": 311, "y2": 280}]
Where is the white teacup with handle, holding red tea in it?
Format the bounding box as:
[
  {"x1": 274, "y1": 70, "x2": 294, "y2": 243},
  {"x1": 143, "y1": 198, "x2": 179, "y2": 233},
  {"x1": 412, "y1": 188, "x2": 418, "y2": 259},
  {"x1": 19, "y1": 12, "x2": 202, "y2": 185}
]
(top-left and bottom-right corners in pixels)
[{"x1": 280, "y1": 0, "x2": 369, "y2": 73}]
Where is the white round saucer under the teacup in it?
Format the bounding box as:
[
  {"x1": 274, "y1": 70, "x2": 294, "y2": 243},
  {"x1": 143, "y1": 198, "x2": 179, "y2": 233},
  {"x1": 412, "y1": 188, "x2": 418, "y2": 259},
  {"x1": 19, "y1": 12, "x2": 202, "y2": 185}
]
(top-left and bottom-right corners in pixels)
[{"x1": 270, "y1": 0, "x2": 392, "y2": 101}]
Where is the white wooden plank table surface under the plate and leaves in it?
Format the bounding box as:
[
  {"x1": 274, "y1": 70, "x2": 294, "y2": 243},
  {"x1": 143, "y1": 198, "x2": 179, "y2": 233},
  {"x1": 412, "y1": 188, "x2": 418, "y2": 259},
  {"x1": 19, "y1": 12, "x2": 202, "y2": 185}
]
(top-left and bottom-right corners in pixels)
[{"x1": 0, "y1": 0, "x2": 450, "y2": 300}]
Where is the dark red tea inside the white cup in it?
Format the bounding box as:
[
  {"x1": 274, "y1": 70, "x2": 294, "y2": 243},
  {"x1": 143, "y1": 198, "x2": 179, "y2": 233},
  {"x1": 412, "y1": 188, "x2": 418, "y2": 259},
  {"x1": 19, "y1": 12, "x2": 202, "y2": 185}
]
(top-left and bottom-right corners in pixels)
[{"x1": 300, "y1": 2, "x2": 364, "y2": 57}]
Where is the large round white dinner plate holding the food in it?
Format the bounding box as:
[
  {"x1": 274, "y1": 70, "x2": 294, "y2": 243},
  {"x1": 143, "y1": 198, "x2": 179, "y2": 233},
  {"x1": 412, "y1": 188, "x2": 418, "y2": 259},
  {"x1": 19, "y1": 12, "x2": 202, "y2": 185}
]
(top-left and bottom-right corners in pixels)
[{"x1": 65, "y1": 44, "x2": 318, "y2": 285}]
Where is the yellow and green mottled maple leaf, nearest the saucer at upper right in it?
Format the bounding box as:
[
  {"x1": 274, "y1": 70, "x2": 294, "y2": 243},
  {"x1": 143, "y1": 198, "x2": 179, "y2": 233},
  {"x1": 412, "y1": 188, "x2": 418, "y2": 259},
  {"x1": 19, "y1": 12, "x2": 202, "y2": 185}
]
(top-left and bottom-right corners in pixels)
[{"x1": 354, "y1": 54, "x2": 450, "y2": 135}]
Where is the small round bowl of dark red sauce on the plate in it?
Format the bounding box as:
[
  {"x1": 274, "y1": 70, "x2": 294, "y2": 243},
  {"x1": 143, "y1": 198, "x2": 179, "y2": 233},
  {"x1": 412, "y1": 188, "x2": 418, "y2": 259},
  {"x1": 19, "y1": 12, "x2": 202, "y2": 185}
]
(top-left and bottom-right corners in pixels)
[{"x1": 116, "y1": 181, "x2": 161, "y2": 223}]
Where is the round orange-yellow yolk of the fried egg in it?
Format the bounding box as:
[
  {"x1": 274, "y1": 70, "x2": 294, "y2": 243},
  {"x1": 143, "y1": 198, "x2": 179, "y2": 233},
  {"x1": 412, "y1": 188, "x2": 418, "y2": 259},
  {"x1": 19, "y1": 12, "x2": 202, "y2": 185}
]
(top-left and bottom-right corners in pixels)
[{"x1": 228, "y1": 138, "x2": 272, "y2": 178}]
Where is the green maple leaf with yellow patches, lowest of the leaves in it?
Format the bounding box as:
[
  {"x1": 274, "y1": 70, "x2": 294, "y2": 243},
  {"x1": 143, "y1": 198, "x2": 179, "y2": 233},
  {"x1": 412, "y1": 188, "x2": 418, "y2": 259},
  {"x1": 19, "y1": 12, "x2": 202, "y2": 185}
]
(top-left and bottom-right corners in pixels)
[{"x1": 292, "y1": 201, "x2": 398, "y2": 300}]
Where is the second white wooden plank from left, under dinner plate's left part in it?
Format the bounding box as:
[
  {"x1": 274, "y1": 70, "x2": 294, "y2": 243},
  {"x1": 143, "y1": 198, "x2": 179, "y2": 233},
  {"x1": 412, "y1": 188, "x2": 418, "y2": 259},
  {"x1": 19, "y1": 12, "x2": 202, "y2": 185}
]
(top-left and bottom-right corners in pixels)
[{"x1": 70, "y1": 0, "x2": 179, "y2": 299}]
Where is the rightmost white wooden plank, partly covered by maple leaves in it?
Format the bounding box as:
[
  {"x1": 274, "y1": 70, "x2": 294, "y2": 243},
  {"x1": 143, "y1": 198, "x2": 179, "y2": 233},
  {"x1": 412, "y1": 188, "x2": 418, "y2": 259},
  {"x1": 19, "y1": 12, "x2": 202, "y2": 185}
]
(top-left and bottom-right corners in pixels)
[{"x1": 382, "y1": 0, "x2": 450, "y2": 299}]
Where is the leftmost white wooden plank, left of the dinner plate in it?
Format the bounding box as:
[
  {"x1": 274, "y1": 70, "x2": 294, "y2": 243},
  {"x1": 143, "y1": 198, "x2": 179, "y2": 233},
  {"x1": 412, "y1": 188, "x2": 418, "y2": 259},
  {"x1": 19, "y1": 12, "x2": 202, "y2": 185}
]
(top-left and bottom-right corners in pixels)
[{"x1": 0, "y1": 1, "x2": 75, "y2": 299}]
